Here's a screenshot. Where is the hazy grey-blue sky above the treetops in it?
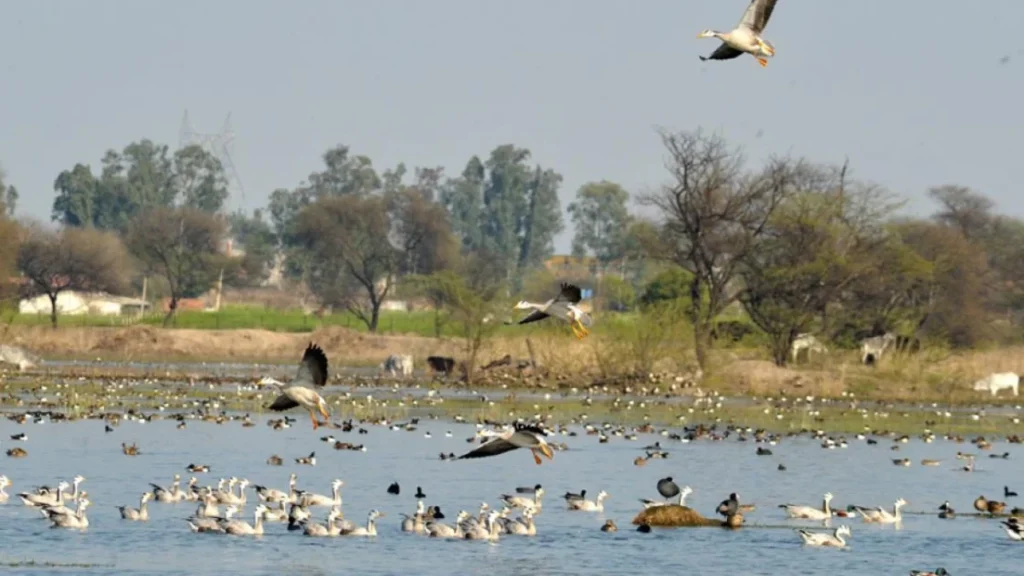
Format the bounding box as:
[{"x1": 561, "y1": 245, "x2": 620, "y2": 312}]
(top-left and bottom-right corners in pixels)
[{"x1": 0, "y1": 0, "x2": 1024, "y2": 251}]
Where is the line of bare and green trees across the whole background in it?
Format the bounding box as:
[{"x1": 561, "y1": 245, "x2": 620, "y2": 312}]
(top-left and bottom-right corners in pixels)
[{"x1": 0, "y1": 129, "x2": 1024, "y2": 367}]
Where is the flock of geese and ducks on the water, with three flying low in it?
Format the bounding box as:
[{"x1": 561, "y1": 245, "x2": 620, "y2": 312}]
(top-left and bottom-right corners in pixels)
[{"x1": 0, "y1": 282, "x2": 1024, "y2": 576}]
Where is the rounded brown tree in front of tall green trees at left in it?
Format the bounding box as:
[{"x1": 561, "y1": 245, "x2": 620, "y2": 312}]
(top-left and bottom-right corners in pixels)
[{"x1": 127, "y1": 207, "x2": 227, "y2": 327}]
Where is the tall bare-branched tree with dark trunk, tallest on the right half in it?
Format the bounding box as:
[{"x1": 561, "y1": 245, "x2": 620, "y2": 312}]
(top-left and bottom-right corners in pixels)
[{"x1": 644, "y1": 126, "x2": 793, "y2": 370}]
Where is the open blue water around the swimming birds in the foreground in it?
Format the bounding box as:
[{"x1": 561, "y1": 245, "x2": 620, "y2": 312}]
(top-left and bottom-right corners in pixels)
[{"x1": 0, "y1": 415, "x2": 1024, "y2": 576}]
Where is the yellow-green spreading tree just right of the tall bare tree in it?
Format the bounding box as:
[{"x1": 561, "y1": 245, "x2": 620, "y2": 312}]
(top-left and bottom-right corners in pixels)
[{"x1": 739, "y1": 161, "x2": 894, "y2": 366}]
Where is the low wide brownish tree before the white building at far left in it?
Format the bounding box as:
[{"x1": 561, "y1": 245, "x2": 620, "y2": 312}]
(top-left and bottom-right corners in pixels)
[{"x1": 17, "y1": 227, "x2": 129, "y2": 329}]
